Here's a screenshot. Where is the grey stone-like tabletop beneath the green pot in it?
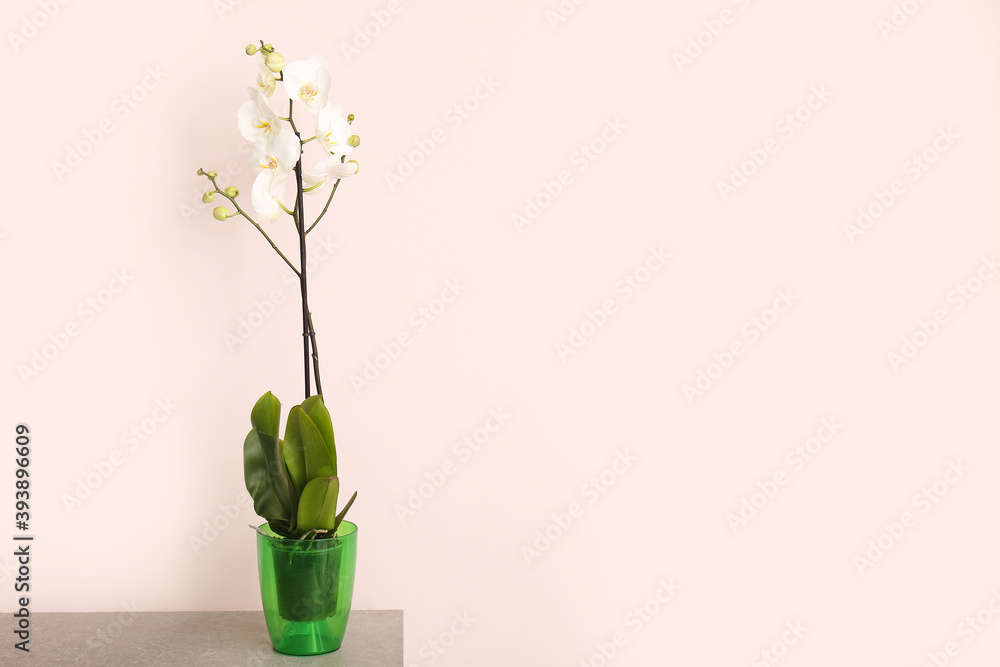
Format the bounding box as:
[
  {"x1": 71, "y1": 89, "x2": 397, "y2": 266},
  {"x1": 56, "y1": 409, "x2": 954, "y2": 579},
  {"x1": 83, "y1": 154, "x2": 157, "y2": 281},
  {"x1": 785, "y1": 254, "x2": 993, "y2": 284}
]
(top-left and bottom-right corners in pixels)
[{"x1": 7, "y1": 610, "x2": 403, "y2": 667}]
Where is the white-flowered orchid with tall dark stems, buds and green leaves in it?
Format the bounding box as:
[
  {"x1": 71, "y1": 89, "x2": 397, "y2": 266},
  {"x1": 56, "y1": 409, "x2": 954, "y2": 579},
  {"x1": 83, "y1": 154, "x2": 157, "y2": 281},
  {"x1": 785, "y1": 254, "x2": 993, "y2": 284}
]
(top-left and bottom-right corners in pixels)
[{"x1": 198, "y1": 41, "x2": 361, "y2": 539}]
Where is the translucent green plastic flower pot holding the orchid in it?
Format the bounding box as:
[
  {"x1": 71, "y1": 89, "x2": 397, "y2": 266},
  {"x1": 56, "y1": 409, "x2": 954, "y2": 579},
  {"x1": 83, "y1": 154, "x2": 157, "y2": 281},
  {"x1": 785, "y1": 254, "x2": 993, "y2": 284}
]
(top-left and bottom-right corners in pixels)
[{"x1": 257, "y1": 521, "x2": 358, "y2": 655}]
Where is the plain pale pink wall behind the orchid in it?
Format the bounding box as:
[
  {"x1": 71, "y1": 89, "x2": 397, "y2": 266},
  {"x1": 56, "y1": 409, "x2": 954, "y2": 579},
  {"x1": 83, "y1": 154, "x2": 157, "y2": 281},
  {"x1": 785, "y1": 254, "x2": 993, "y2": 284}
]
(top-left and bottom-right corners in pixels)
[{"x1": 0, "y1": 0, "x2": 1000, "y2": 667}]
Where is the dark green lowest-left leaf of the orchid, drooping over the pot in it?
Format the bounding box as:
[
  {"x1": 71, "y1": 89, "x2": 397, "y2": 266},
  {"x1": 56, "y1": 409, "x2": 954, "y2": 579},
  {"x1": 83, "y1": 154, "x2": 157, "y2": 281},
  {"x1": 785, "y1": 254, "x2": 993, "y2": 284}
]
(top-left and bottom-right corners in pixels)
[{"x1": 243, "y1": 429, "x2": 298, "y2": 534}]
